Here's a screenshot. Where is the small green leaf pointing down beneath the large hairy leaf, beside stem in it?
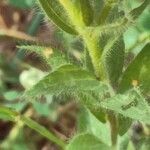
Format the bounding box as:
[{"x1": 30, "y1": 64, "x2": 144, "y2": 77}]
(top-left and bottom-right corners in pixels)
[{"x1": 74, "y1": 82, "x2": 109, "y2": 123}]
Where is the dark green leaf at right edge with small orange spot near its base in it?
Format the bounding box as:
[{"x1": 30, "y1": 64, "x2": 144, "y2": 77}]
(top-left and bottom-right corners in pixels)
[{"x1": 119, "y1": 43, "x2": 150, "y2": 94}]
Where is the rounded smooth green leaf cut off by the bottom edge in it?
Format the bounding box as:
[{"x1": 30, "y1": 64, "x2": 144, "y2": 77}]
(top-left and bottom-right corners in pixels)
[{"x1": 66, "y1": 133, "x2": 110, "y2": 150}]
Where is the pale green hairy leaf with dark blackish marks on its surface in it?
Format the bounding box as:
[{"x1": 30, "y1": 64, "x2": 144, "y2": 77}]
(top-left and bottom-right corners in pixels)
[{"x1": 101, "y1": 89, "x2": 150, "y2": 124}]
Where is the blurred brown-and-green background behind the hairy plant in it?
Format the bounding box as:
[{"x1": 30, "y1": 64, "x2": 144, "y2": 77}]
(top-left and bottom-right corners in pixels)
[{"x1": 0, "y1": 0, "x2": 150, "y2": 150}]
